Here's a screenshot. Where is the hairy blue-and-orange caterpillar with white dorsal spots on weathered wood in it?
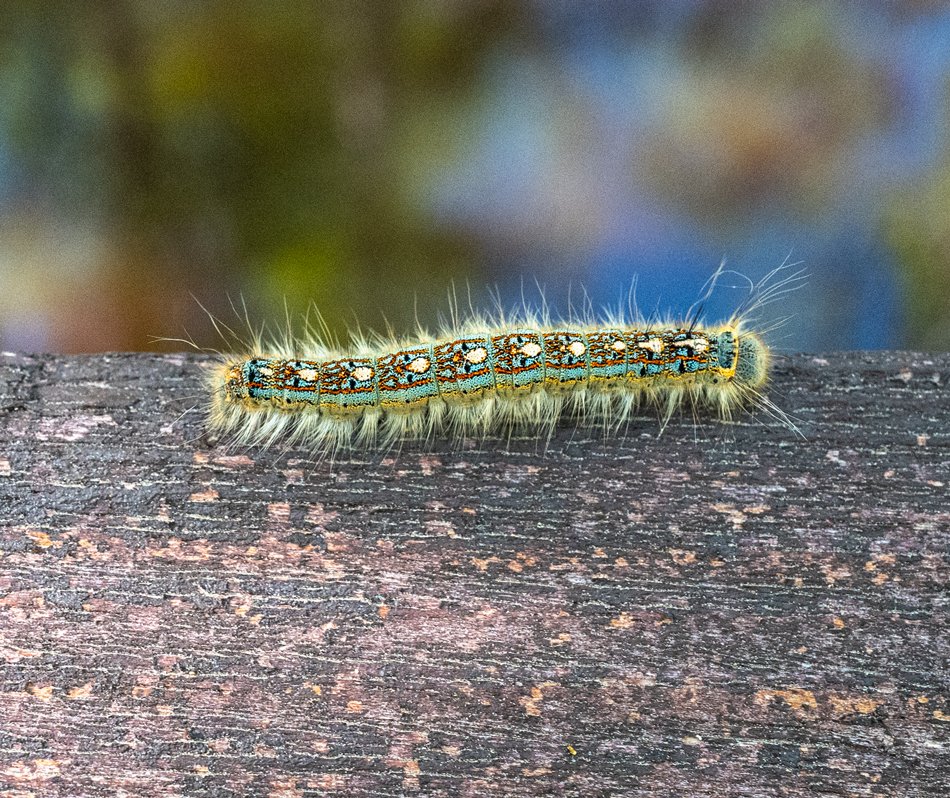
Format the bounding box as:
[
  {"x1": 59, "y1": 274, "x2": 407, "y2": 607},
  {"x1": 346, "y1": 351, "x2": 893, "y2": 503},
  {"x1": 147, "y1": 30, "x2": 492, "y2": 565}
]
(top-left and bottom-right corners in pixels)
[{"x1": 208, "y1": 265, "x2": 803, "y2": 454}]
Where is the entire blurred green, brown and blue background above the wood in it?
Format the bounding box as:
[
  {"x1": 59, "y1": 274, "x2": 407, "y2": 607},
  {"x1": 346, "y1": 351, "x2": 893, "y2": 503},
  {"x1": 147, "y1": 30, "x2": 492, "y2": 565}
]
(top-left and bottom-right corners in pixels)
[{"x1": 0, "y1": 0, "x2": 950, "y2": 352}]
